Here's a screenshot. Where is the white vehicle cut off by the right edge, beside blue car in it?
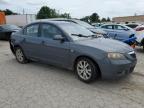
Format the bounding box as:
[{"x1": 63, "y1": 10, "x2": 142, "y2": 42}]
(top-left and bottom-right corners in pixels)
[{"x1": 136, "y1": 25, "x2": 144, "y2": 50}]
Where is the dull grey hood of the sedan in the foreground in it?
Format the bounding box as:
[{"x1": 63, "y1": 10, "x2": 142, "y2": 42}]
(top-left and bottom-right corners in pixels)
[{"x1": 77, "y1": 38, "x2": 133, "y2": 53}]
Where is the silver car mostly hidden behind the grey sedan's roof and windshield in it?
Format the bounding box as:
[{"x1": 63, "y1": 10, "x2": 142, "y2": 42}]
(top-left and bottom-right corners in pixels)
[{"x1": 46, "y1": 18, "x2": 108, "y2": 38}]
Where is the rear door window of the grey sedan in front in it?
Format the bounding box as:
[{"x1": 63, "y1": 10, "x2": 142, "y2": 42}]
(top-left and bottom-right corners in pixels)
[{"x1": 24, "y1": 24, "x2": 39, "y2": 37}]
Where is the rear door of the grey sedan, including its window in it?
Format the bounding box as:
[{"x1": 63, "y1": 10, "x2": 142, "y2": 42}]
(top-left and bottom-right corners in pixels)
[{"x1": 21, "y1": 23, "x2": 42, "y2": 59}]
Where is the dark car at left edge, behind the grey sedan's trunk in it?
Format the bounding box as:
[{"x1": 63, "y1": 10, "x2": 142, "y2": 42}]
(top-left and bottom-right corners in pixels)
[{"x1": 0, "y1": 24, "x2": 20, "y2": 40}]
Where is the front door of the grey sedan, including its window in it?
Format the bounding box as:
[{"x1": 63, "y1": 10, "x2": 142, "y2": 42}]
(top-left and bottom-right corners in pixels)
[{"x1": 40, "y1": 23, "x2": 70, "y2": 66}]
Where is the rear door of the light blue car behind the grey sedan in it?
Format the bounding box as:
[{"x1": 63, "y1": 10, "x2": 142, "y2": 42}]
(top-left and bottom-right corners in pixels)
[{"x1": 102, "y1": 25, "x2": 116, "y2": 38}]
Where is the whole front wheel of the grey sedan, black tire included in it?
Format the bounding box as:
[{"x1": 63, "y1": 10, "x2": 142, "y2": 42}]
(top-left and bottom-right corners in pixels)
[{"x1": 75, "y1": 57, "x2": 99, "y2": 83}]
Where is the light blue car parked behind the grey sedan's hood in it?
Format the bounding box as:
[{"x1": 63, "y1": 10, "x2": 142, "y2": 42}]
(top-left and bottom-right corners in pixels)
[{"x1": 101, "y1": 24, "x2": 136, "y2": 45}]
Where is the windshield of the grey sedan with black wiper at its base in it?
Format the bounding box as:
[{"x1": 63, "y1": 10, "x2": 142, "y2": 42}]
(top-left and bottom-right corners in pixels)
[{"x1": 59, "y1": 23, "x2": 94, "y2": 40}]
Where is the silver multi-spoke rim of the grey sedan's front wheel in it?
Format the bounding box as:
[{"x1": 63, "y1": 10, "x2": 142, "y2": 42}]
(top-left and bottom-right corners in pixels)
[{"x1": 77, "y1": 60, "x2": 92, "y2": 80}]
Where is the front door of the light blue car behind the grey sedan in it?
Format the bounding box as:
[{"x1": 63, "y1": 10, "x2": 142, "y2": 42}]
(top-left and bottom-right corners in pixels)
[{"x1": 114, "y1": 25, "x2": 129, "y2": 41}]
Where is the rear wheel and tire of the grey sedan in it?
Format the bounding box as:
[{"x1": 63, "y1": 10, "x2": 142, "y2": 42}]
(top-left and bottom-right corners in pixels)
[{"x1": 15, "y1": 47, "x2": 28, "y2": 64}]
